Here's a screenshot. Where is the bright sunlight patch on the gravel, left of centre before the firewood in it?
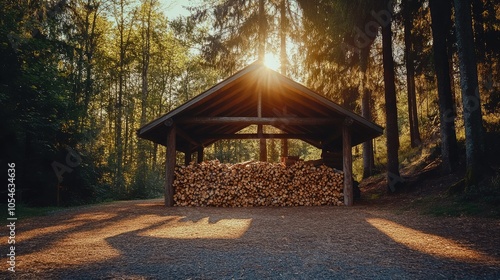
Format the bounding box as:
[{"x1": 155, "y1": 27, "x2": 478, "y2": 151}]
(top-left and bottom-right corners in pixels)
[{"x1": 140, "y1": 217, "x2": 252, "y2": 239}]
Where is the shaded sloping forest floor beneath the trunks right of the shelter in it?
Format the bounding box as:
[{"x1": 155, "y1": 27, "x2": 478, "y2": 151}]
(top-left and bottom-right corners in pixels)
[{"x1": 357, "y1": 155, "x2": 500, "y2": 219}]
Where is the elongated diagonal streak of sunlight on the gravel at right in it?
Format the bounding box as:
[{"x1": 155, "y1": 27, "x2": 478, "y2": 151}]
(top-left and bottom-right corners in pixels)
[{"x1": 366, "y1": 218, "x2": 499, "y2": 263}]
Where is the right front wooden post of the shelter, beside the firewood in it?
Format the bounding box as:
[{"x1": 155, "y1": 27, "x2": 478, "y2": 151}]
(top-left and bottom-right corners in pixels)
[{"x1": 342, "y1": 118, "x2": 354, "y2": 206}]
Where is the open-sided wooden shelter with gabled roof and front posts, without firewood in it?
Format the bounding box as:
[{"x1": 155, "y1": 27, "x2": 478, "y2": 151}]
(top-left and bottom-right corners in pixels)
[{"x1": 137, "y1": 62, "x2": 383, "y2": 206}]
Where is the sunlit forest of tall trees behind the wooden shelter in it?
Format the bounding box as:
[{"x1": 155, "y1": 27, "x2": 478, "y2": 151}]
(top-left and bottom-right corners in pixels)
[{"x1": 0, "y1": 0, "x2": 500, "y2": 205}]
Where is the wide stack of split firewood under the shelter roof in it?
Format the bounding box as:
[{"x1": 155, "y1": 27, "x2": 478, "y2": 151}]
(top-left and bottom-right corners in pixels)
[{"x1": 174, "y1": 160, "x2": 343, "y2": 207}]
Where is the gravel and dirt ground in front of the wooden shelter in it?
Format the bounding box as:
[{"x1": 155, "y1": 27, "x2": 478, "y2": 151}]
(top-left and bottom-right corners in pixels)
[{"x1": 0, "y1": 200, "x2": 500, "y2": 279}]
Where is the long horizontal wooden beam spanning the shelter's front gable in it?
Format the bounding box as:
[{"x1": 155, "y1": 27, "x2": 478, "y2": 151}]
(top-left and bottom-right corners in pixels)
[{"x1": 176, "y1": 117, "x2": 342, "y2": 125}]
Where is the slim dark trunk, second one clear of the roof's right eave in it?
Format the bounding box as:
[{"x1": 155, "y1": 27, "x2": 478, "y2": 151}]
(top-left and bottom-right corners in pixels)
[{"x1": 404, "y1": 7, "x2": 421, "y2": 147}]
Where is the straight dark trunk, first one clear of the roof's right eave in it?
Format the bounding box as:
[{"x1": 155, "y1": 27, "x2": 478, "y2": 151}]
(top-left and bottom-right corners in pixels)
[{"x1": 382, "y1": 13, "x2": 401, "y2": 192}]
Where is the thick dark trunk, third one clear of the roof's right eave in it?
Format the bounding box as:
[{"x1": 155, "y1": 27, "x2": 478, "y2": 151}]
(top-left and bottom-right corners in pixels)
[{"x1": 429, "y1": 0, "x2": 458, "y2": 173}]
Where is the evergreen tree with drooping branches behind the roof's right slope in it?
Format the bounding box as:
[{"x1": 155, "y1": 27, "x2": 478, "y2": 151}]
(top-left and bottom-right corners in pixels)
[{"x1": 299, "y1": 1, "x2": 379, "y2": 178}]
